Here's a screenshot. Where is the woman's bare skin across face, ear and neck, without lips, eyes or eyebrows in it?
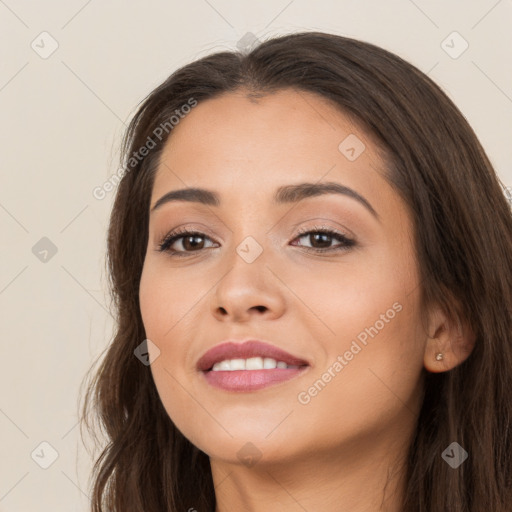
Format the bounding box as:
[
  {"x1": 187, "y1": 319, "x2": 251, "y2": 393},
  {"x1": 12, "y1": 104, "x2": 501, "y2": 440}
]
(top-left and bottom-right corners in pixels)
[{"x1": 140, "y1": 90, "x2": 471, "y2": 512}]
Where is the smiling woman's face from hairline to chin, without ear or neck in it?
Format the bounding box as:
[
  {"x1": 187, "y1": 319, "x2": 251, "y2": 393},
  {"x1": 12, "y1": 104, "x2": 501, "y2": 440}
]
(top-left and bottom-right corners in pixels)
[{"x1": 140, "y1": 90, "x2": 427, "y2": 464}]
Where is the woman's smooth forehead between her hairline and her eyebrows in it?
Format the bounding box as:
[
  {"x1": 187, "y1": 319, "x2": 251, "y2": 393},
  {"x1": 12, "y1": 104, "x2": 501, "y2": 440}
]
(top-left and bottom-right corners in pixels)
[{"x1": 153, "y1": 89, "x2": 383, "y2": 205}]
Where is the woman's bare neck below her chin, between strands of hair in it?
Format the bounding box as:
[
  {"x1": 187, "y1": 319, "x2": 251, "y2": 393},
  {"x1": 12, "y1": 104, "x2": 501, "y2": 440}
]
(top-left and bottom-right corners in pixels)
[{"x1": 210, "y1": 428, "x2": 408, "y2": 512}]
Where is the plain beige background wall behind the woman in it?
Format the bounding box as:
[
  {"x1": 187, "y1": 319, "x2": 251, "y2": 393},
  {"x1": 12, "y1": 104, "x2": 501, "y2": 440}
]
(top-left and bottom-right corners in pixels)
[{"x1": 0, "y1": 0, "x2": 512, "y2": 512}]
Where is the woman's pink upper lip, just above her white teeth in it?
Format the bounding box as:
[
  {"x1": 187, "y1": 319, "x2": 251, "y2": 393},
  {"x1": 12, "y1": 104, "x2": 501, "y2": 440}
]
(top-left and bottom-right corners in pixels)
[{"x1": 196, "y1": 340, "x2": 309, "y2": 372}]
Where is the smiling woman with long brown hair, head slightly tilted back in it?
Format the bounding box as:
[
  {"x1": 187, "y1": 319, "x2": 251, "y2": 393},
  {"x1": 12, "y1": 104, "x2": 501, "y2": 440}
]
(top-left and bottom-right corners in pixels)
[{"x1": 80, "y1": 33, "x2": 512, "y2": 512}]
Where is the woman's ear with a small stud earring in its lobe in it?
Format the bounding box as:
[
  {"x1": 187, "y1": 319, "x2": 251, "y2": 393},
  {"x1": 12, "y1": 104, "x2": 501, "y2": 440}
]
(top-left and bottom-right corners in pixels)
[{"x1": 423, "y1": 306, "x2": 476, "y2": 373}]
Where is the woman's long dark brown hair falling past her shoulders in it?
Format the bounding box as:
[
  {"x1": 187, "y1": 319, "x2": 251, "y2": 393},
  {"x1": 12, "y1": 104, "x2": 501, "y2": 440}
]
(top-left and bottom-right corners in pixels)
[{"x1": 82, "y1": 32, "x2": 512, "y2": 512}]
